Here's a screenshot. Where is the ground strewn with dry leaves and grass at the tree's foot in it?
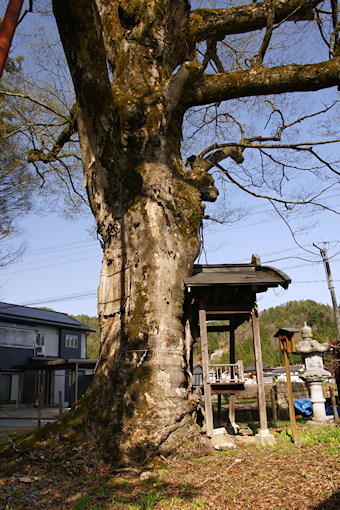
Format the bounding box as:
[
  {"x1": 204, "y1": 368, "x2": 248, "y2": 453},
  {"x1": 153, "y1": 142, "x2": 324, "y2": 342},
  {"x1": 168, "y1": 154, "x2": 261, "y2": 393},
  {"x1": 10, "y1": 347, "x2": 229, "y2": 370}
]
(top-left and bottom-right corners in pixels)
[{"x1": 0, "y1": 425, "x2": 340, "y2": 510}]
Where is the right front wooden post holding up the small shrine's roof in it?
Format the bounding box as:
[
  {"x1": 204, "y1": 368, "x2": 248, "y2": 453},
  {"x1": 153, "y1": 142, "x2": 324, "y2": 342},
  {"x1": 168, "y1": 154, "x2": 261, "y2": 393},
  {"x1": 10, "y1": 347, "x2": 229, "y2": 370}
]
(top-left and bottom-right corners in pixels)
[{"x1": 251, "y1": 309, "x2": 268, "y2": 430}]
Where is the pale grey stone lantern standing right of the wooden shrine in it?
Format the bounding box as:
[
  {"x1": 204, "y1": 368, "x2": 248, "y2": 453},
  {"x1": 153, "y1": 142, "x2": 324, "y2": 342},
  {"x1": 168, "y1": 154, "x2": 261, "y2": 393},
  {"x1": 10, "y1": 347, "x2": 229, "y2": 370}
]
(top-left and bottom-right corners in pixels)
[{"x1": 296, "y1": 323, "x2": 329, "y2": 423}]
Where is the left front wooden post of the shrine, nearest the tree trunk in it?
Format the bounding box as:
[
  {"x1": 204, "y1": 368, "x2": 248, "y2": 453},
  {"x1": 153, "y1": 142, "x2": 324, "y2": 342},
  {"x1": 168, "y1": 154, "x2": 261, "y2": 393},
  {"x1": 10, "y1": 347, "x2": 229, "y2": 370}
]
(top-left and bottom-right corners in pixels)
[{"x1": 199, "y1": 299, "x2": 214, "y2": 437}]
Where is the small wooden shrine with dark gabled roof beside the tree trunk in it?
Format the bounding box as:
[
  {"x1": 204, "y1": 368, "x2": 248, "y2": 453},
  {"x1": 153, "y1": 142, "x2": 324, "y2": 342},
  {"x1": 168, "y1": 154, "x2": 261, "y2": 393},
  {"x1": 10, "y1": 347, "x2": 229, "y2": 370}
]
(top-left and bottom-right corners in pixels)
[{"x1": 184, "y1": 255, "x2": 291, "y2": 442}]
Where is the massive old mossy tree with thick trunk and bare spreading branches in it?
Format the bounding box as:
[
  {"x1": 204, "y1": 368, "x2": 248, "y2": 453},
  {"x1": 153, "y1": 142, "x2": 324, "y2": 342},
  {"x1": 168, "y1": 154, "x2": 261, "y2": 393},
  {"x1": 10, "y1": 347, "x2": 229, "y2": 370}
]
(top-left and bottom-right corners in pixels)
[{"x1": 28, "y1": 0, "x2": 340, "y2": 461}]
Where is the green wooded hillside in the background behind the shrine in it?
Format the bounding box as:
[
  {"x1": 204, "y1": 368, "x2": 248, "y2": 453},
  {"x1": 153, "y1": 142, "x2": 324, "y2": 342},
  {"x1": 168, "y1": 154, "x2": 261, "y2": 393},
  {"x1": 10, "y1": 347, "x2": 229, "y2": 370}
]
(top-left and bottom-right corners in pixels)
[{"x1": 75, "y1": 299, "x2": 337, "y2": 367}]
